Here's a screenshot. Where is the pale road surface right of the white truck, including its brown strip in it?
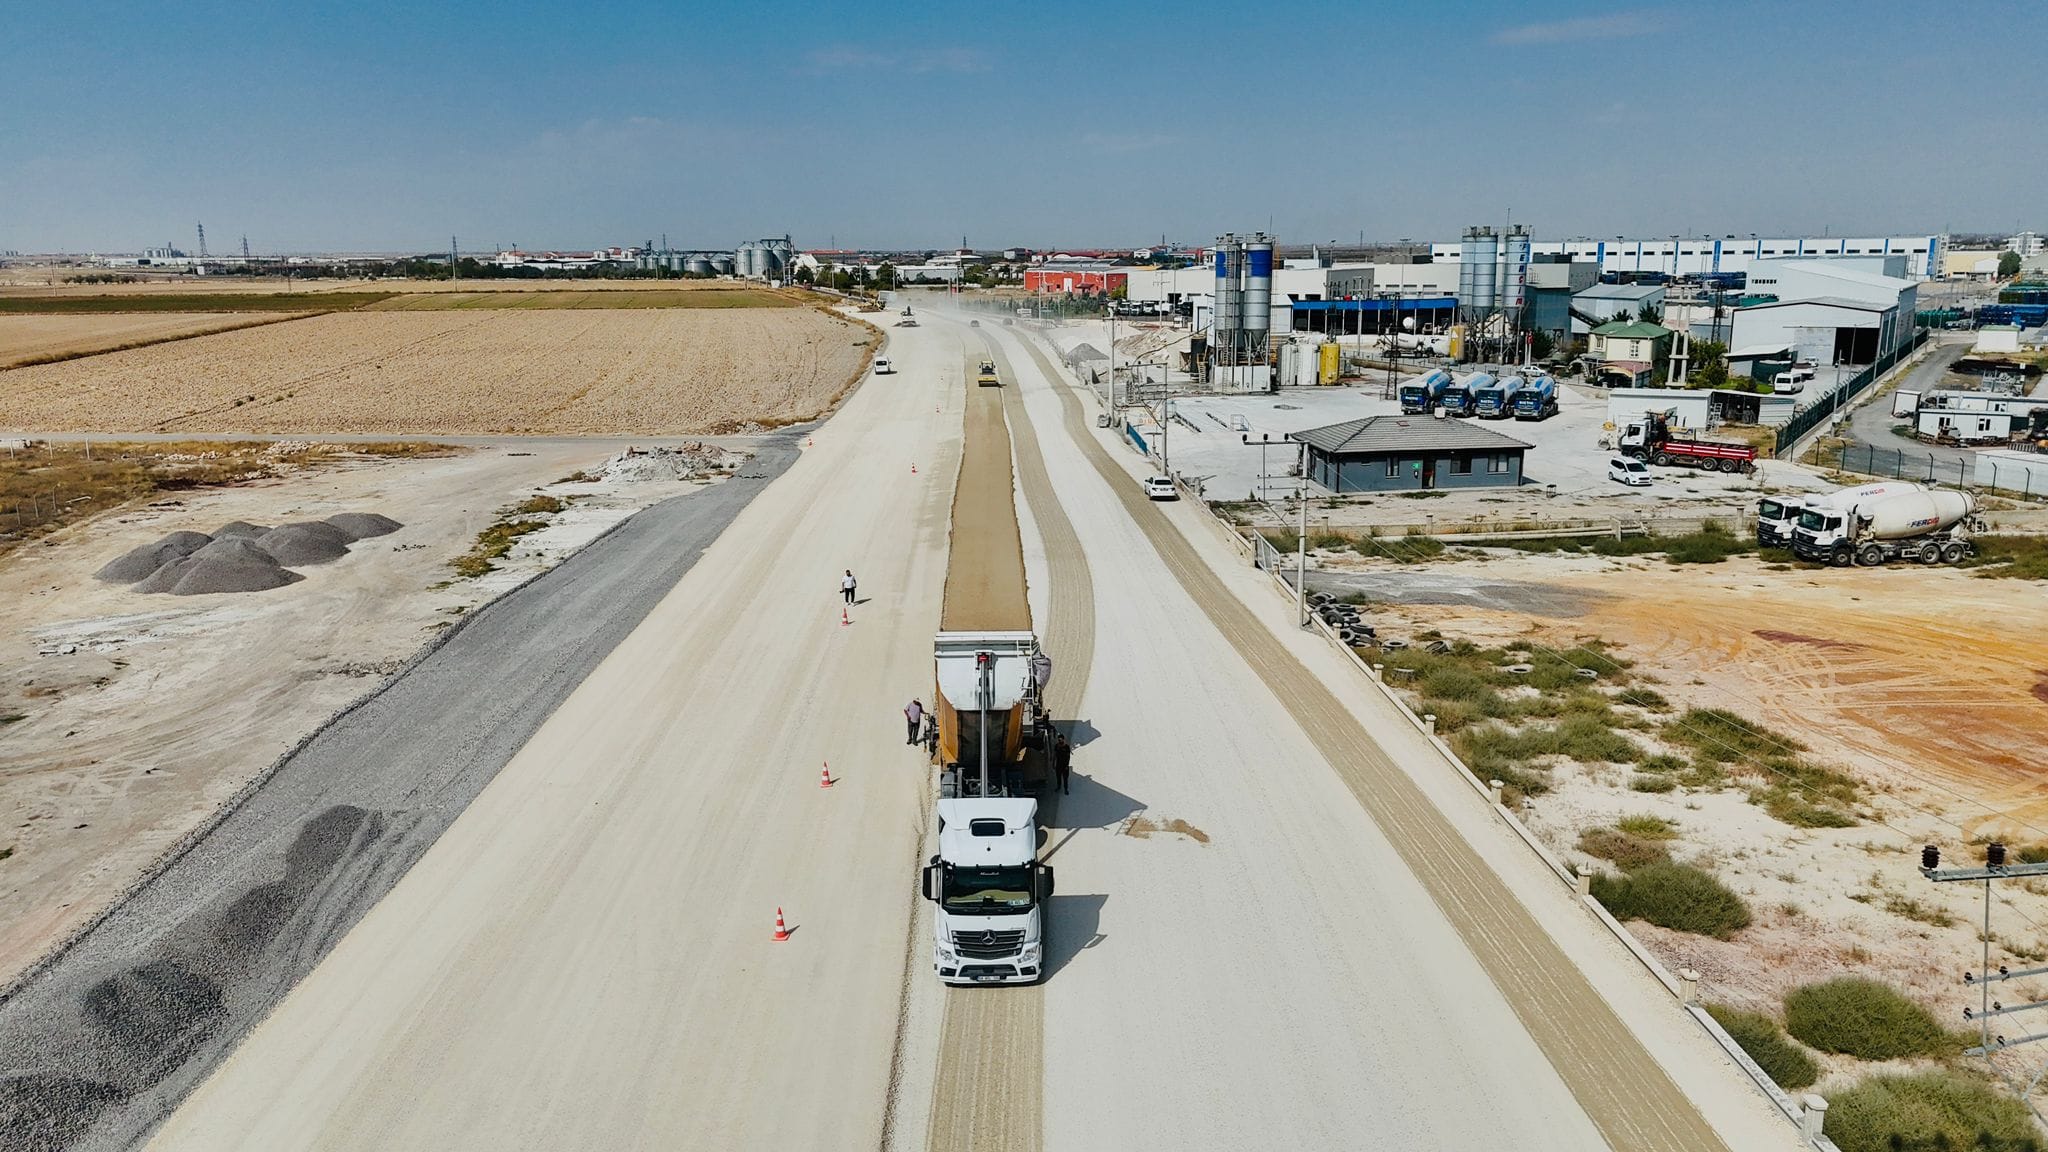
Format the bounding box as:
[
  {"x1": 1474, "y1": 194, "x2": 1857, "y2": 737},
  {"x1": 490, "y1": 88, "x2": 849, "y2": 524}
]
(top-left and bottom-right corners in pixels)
[{"x1": 929, "y1": 313, "x2": 1794, "y2": 1150}]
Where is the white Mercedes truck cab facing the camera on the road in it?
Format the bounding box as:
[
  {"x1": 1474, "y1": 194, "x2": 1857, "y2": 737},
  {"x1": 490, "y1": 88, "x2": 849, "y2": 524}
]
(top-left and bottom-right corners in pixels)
[{"x1": 920, "y1": 797, "x2": 1053, "y2": 984}]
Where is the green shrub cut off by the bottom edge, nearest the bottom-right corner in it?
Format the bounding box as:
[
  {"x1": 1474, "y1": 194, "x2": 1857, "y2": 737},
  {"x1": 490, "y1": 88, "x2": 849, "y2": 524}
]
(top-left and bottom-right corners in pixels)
[{"x1": 1827, "y1": 1072, "x2": 2044, "y2": 1152}]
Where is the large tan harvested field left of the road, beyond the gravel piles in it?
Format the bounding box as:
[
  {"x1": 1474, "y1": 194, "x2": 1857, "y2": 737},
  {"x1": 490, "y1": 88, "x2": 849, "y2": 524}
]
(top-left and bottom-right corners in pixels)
[{"x1": 0, "y1": 307, "x2": 879, "y2": 435}]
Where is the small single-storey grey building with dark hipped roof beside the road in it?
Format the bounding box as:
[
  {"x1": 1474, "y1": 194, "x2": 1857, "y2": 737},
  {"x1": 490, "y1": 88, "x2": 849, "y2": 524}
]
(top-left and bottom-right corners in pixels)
[{"x1": 1288, "y1": 416, "x2": 1530, "y2": 496}]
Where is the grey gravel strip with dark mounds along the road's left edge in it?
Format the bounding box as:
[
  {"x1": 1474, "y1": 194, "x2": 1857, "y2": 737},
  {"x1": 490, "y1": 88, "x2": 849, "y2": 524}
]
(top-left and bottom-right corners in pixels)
[{"x1": 0, "y1": 428, "x2": 803, "y2": 1152}]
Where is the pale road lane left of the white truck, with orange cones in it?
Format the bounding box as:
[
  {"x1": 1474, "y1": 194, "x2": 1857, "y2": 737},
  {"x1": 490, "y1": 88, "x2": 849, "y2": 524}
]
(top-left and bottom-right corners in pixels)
[{"x1": 154, "y1": 319, "x2": 961, "y2": 1150}]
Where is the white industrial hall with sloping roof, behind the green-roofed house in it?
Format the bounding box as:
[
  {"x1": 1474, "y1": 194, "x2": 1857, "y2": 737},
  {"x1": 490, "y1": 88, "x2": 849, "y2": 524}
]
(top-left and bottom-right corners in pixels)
[{"x1": 1731, "y1": 260, "x2": 1917, "y2": 365}]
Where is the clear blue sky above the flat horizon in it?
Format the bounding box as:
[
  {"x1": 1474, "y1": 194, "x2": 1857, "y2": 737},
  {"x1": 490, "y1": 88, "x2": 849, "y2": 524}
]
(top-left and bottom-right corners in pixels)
[{"x1": 0, "y1": 0, "x2": 2048, "y2": 252}]
